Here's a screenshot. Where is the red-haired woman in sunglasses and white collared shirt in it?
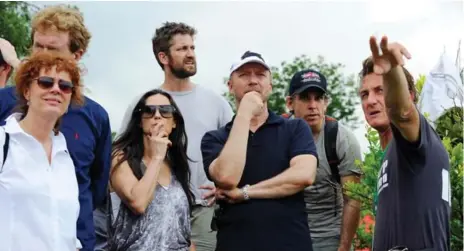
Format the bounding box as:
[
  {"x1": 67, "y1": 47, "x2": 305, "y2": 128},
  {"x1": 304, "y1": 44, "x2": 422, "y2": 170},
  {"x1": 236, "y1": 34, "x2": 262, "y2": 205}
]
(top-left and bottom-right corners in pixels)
[{"x1": 0, "y1": 52, "x2": 82, "y2": 251}]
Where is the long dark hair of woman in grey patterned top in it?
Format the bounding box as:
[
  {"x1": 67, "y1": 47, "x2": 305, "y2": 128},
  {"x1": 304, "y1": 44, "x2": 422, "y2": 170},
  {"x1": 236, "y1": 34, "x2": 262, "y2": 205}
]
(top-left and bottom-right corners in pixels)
[{"x1": 111, "y1": 89, "x2": 194, "y2": 212}]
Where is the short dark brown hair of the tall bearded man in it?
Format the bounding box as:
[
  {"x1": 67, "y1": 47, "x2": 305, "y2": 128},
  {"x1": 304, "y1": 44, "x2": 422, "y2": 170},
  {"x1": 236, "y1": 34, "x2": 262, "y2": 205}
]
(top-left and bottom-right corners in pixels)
[{"x1": 151, "y1": 22, "x2": 197, "y2": 71}]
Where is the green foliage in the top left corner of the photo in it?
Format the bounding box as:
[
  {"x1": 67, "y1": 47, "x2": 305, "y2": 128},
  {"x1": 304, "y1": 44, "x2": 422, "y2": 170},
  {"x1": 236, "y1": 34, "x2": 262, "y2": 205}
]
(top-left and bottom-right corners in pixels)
[{"x1": 0, "y1": 1, "x2": 32, "y2": 57}]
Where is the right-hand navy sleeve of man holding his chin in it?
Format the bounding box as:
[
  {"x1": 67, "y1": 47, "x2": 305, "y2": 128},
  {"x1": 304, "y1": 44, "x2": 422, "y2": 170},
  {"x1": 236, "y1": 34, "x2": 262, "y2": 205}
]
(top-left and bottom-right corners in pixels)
[{"x1": 288, "y1": 119, "x2": 318, "y2": 159}]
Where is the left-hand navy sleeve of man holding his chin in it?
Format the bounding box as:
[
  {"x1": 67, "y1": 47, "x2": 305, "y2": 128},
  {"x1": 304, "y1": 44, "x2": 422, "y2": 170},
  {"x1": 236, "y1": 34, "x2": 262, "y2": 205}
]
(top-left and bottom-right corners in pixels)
[{"x1": 201, "y1": 130, "x2": 226, "y2": 181}]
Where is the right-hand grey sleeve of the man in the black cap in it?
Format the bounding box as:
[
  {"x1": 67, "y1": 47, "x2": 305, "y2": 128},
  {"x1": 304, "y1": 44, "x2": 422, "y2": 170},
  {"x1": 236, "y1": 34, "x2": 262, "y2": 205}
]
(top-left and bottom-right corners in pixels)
[{"x1": 336, "y1": 123, "x2": 362, "y2": 176}]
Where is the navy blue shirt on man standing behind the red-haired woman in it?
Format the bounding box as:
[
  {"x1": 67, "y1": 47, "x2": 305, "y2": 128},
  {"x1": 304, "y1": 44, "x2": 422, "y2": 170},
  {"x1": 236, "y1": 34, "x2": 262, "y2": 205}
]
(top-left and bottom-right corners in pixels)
[{"x1": 0, "y1": 87, "x2": 112, "y2": 251}]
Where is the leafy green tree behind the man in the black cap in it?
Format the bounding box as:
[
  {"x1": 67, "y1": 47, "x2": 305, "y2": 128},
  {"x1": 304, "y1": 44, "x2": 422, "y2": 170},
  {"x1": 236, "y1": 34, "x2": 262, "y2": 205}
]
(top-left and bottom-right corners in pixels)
[{"x1": 223, "y1": 55, "x2": 360, "y2": 129}]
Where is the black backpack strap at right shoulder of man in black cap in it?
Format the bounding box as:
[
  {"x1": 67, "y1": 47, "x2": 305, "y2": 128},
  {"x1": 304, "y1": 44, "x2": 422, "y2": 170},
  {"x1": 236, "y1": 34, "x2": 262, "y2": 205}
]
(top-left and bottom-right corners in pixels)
[{"x1": 324, "y1": 116, "x2": 341, "y2": 184}]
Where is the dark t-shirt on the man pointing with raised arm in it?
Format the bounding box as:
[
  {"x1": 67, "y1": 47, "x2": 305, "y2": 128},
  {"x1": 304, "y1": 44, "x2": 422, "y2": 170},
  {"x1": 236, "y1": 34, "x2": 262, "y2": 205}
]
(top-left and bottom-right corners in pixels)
[{"x1": 373, "y1": 114, "x2": 451, "y2": 251}]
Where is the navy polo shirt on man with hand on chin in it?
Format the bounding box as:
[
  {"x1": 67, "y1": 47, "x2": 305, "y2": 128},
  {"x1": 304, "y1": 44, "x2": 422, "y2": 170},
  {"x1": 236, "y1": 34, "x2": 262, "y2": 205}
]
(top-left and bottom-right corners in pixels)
[{"x1": 201, "y1": 111, "x2": 317, "y2": 251}]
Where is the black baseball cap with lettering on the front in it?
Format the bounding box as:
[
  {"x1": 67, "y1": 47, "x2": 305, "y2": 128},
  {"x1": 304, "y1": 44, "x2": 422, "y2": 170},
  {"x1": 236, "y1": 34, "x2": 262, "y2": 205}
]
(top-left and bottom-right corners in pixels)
[{"x1": 288, "y1": 69, "x2": 327, "y2": 96}]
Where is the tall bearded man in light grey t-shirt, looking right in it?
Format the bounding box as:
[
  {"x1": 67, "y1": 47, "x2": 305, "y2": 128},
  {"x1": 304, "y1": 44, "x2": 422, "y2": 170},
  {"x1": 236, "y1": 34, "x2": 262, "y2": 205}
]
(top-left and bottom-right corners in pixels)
[{"x1": 98, "y1": 22, "x2": 233, "y2": 251}]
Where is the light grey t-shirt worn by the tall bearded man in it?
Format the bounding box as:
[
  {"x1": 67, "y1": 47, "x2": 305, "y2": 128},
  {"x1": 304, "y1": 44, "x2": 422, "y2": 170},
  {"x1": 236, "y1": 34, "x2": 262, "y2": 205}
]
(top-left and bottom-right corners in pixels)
[{"x1": 119, "y1": 85, "x2": 233, "y2": 205}]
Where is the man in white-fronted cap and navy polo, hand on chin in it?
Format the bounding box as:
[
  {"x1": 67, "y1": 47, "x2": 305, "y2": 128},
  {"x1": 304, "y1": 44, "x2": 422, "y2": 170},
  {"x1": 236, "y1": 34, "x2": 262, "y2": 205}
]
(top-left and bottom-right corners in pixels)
[{"x1": 201, "y1": 52, "x2": 317, "y2": 251}]
